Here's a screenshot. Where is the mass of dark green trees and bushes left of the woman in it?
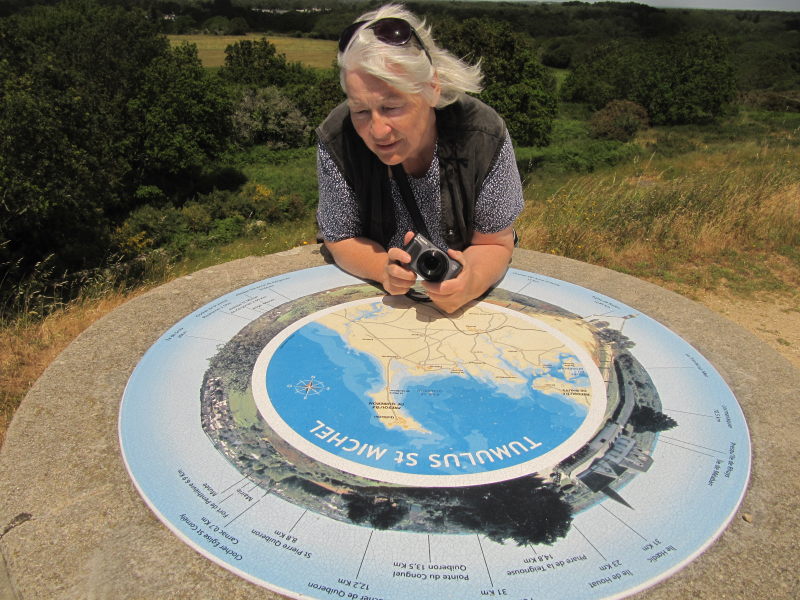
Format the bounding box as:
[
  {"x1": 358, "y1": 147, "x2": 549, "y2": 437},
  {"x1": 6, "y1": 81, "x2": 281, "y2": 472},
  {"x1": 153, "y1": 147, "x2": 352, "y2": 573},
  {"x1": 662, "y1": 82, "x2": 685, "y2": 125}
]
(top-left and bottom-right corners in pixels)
[{"x1": 0, "y1": 0, "x2": 343, "y2": 311}]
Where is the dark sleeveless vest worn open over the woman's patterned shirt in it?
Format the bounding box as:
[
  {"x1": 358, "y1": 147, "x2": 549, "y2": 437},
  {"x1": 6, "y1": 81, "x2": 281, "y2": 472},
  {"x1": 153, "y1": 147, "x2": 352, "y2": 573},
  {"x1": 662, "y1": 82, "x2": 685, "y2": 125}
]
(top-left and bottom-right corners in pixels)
[{"x1": 317, "y1": 96, "x2": 506, "y2": 250}]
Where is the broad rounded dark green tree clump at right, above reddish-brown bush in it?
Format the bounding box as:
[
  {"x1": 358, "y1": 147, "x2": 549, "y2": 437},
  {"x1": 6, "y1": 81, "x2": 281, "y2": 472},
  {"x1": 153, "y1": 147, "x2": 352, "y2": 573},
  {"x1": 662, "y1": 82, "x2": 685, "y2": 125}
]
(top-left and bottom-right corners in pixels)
[{"x1": 562, "y1": 34, "x2": 734, "y2": 124}]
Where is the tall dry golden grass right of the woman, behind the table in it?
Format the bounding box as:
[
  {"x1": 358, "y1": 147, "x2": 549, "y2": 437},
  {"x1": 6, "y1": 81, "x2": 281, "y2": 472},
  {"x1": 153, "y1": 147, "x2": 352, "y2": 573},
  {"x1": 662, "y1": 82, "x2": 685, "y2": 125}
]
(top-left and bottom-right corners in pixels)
[{"x1": 518, "y1": 139, "x2": 800, "y2": 295}]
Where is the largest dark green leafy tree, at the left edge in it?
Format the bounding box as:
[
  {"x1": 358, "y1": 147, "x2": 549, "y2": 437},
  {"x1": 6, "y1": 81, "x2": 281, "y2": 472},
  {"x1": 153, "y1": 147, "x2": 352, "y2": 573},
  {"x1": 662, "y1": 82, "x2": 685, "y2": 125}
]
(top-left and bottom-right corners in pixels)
[{"x1": 0, "y1": 0, "x2": 227, "y2": 290}]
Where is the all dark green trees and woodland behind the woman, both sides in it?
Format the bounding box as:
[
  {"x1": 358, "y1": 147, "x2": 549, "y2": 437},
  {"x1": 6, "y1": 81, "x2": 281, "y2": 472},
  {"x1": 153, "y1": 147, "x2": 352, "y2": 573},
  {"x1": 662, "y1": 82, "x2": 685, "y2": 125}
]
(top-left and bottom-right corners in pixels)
[{"x1": 0, "y1": 0, "x2": 800, "y2": 318}]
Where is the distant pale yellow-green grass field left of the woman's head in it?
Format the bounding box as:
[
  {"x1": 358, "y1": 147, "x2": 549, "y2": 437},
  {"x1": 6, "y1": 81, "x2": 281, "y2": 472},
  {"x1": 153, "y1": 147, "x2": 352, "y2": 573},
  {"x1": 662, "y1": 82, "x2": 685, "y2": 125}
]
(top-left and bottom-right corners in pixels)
[{"x1": 167, "y1": 33, "x2": 336, "y2": 69}]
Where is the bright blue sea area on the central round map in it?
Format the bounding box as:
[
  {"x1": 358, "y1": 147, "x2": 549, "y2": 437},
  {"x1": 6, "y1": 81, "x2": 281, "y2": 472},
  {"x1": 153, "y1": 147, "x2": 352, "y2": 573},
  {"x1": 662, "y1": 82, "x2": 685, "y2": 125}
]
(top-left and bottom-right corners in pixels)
[{"x1": 266, "y1": 322, "x2": 588, "y2": 475}]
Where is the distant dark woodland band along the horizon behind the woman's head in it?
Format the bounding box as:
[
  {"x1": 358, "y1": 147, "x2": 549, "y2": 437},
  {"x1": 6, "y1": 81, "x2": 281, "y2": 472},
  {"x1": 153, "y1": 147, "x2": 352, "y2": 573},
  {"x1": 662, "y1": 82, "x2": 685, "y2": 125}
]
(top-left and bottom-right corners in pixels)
[{"x1": 126, "y1": 0, "x2": 800, "y2": 90}]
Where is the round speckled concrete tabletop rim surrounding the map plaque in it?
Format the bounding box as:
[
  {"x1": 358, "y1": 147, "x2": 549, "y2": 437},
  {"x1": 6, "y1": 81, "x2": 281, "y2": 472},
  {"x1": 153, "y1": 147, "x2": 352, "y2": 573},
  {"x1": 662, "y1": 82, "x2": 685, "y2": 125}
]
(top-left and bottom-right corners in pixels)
[{"x1": 0, "y1": 246, "x2": 800, "y2": 600}]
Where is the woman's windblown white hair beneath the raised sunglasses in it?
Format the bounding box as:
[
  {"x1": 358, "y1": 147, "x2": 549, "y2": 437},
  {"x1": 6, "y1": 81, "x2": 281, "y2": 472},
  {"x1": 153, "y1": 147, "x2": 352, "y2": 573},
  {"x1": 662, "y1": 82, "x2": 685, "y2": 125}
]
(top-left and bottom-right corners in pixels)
[{"x1": 337, "y1": 4, "x2": 483, "y2": 108}]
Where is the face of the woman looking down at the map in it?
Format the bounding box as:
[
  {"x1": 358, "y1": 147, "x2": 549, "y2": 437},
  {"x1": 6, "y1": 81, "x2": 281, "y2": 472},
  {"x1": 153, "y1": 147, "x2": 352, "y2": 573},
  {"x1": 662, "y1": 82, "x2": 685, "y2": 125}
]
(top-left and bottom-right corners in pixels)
[{"x1": 345, "y1": 71, "x2": 439, "y2": 175}]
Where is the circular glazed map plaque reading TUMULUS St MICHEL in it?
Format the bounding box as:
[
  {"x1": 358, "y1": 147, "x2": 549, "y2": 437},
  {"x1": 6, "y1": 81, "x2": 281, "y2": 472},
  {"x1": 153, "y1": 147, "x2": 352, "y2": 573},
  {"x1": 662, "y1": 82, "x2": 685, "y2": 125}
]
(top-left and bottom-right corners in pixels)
[{"x1": 119, "y1": 266, "x2": 750, "y2": 600}]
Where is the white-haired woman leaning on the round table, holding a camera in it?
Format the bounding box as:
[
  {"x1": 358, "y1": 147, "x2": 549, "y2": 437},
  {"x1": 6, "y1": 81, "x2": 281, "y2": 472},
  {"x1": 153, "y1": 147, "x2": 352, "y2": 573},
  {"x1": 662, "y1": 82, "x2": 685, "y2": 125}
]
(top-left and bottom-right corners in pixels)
[{"x1": 317, "y1": 5, "x2": 522, "y2": 313}]
